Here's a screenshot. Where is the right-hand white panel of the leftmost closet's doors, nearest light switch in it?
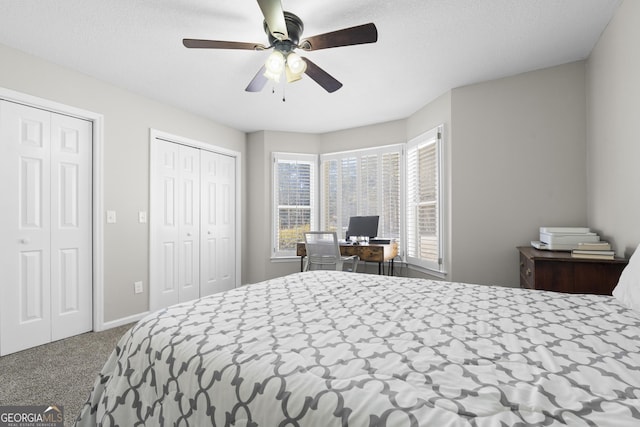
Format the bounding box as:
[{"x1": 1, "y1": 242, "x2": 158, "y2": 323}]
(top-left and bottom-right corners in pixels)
[{"x1": 51, "y1": 114, "x2": 93, "y2": 341}]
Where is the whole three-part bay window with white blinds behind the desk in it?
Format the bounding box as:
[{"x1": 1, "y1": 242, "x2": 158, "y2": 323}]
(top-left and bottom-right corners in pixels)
[{"x1": 272, "y1": 126, "x2": 444, "y2": 272}]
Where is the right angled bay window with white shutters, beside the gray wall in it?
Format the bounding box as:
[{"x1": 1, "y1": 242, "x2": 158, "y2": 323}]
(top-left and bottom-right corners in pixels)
[{"x1": 406, "y1": 126, "x2": 443, "y2": 271}]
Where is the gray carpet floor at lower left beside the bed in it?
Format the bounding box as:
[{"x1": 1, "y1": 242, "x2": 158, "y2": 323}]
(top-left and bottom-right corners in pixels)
[{"x1": 0, "y1": 325, "x2": 133, "y2": 426}]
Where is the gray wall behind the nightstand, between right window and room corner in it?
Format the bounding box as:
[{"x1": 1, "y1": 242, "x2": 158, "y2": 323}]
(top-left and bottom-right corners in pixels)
[{"x1": 450, "y1": 61, "x2": 587, "y2": 286}]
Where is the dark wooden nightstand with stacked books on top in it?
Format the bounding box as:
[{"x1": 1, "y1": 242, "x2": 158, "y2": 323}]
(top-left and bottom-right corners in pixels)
[{"x1": 518, "y1": 246, "x2": 628, "y2": 295}]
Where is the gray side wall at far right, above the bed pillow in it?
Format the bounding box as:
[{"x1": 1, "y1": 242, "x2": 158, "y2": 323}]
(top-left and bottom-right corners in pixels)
[{"x1": 587, "y1": 0, "x2": 640, "y2": 257}]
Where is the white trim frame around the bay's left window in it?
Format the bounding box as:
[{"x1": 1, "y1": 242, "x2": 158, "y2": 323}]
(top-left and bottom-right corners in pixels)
[{"x1": 271, "y1": 152, "x2": 320, "y2": 261}]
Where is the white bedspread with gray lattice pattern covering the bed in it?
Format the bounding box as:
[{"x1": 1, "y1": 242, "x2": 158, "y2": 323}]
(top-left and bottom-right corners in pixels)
[{"x1": 77, "y1": 272, "x2": 640, "y2": 427}]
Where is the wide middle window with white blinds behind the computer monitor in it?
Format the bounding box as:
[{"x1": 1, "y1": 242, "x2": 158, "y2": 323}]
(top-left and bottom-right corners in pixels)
[{"x1": 320, "y1": 145, "x2": 402, "y2": 241}]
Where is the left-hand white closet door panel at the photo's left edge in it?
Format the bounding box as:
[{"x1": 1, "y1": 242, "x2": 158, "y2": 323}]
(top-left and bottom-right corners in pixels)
[{"x1": 0, "y1": 101, "x2": 51, "y2": 354}]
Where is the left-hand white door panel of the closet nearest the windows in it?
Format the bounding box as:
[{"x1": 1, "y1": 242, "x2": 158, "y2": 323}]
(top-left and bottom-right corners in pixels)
[{"x1": 150, "y1": 140, "x2": 200, "y2": 310}]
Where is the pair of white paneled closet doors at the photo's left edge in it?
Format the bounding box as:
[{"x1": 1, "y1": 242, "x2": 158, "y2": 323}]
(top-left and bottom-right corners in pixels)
[{"x1": 0, "y1": 101, "x2": 93, "y2": 354}]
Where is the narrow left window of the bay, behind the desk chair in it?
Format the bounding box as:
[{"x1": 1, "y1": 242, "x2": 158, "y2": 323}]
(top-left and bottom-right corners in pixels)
[{"x1": 272, "y1": 153, "x2": 318, "y2": 257}]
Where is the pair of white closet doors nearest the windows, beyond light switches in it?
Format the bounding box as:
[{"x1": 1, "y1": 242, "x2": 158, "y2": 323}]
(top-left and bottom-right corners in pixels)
[{"x1": 149, "y1": 138, "x2": 237, "y2": 310}]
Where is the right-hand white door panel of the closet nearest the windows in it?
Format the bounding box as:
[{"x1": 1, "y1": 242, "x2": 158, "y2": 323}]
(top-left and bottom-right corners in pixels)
[{"x1": 200, "y1": 150, "x2": 236, "y2": 296}]
